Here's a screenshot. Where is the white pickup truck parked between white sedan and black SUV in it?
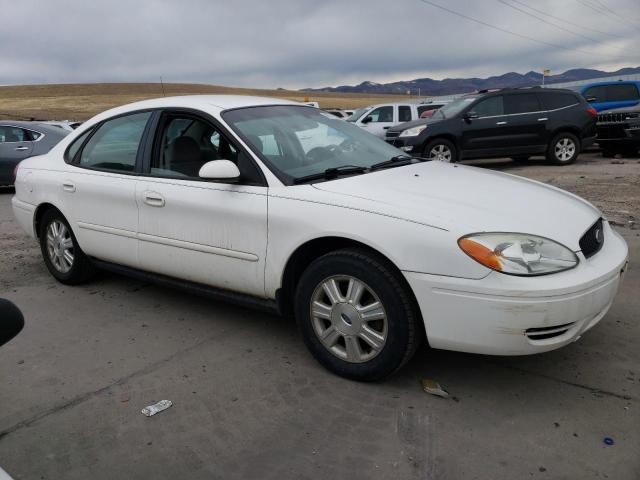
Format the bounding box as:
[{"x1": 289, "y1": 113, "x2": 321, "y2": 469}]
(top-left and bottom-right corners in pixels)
[{"x1": 347, "y1": 103, "x2": 442, "y2": 138}]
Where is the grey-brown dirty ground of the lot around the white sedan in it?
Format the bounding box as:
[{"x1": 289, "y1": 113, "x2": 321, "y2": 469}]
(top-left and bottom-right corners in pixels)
[{"x1": 0, "y1": 154, "x2": 640, "y2": 480}]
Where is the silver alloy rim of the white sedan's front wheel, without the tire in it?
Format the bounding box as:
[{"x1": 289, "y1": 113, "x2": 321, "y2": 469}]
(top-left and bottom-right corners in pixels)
[{"x1": 310, "y1": 275, "x2": 388, "y2": 363}]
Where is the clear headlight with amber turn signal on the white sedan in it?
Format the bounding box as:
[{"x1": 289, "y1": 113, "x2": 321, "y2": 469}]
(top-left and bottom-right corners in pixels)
[{"x1": 458, "y1": 233, "x2": 578, "y2": 276}]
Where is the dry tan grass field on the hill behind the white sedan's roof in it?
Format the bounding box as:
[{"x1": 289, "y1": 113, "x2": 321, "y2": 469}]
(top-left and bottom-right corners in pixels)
[{"x1": 0, "y1": 83, "x2": 409, "y2": 120}]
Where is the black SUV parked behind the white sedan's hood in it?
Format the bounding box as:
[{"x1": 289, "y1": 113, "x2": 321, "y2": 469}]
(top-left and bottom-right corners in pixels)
[{"x1": 385, "y1": 87, "x2": 597, "y2": 164}]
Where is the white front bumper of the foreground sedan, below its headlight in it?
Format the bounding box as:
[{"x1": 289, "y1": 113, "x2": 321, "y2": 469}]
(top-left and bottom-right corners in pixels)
[{"x1": 403, "y1": 223, "x2": 628, "y2": 355}]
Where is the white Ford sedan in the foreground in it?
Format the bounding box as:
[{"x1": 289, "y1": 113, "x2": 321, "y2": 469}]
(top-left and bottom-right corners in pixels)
[{"x1": 12, "y1": 96, "x2": 628, "y2": 380}]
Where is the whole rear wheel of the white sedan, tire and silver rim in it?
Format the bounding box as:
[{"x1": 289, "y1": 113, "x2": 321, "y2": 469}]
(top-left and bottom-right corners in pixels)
[{"x1": 40, "y1": 209, "x2": 94, "y2": 285}]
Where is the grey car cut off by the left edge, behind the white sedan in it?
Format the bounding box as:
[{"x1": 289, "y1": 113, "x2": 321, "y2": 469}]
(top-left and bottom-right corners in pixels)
[{"x1": 0, "y1": 120, "x2": 69, "y2": 187}]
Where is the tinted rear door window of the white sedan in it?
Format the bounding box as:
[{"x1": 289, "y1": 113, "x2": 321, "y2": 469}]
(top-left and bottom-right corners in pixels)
[{"x1": 78, "y1": 112, "x2": 151, "y2": 172}]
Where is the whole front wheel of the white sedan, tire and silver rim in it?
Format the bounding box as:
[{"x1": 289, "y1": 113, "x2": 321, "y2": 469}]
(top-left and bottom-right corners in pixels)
[{"x1": 295, "y1": 249, "x2": 421, "y2": 381}]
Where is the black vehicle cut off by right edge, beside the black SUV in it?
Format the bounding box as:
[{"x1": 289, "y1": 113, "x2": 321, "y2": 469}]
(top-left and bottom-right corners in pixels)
[{"x1": 597, "y1": 105, "x2": 640, "y2": 157}]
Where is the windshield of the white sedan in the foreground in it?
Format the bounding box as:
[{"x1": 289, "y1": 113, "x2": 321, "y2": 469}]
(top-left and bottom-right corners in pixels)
[{"x1": 223, "y1": 106, "x2": 403, "y2": 183}]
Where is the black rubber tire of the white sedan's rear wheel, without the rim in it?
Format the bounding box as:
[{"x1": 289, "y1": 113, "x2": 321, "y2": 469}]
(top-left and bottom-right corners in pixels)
[{"x1": 39, "y1": 208, "x2": 95, "y2": 285}]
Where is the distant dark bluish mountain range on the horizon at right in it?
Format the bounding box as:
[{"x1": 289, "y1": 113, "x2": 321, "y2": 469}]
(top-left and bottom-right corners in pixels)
[{"x1": 303, "y1": 67, "x2": 640, "y2": 96}]
